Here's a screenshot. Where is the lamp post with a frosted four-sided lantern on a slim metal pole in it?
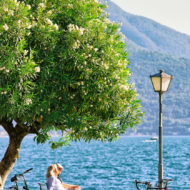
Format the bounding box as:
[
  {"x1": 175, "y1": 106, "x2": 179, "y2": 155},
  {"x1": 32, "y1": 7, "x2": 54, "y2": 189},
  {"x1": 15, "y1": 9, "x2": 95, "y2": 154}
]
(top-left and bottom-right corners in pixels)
[{"x1": 150, "y1": 70, "x2": 172, "y2": 188}]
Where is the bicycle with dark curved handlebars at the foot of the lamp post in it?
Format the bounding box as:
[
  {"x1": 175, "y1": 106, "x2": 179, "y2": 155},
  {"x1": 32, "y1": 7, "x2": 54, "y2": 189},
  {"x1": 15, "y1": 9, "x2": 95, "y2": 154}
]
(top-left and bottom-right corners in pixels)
[{"x1": 135, "y1": 179, "x2": 172, "y2": 190}]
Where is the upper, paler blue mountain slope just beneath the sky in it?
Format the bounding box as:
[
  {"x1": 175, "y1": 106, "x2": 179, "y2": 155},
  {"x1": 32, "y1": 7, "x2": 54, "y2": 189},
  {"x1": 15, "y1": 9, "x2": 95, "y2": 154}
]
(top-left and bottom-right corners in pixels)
[{"x1": 106, "y1": 1, "x2": 190, "y2": 58}]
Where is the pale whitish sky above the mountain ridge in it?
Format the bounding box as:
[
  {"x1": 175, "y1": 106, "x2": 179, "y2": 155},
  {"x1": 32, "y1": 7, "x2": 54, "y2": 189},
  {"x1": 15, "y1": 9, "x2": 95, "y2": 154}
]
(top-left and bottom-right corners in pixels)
[{"x1": 112, "y1": 0, "x2": 190, "y2": 35}]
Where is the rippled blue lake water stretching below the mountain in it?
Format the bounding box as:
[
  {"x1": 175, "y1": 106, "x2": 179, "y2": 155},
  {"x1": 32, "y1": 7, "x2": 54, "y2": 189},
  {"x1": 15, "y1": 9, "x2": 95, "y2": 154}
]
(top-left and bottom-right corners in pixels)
[{"x1": 0, "y1": 136, "x2": 190, "y2": 190}]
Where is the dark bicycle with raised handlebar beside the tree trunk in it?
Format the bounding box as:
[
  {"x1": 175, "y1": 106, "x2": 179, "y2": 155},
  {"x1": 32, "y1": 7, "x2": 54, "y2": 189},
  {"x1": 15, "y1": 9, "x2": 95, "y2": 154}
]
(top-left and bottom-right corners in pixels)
[{"x1": 9, "y1": 168, "x2": 33, "y2": 190}]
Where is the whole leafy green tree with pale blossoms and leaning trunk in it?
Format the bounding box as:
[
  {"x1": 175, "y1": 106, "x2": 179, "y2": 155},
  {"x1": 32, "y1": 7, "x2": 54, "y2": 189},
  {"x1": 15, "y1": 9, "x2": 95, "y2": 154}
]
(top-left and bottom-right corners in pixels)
[{"x1": 0, "y1": 0, "x2": 142, "y2": 189}]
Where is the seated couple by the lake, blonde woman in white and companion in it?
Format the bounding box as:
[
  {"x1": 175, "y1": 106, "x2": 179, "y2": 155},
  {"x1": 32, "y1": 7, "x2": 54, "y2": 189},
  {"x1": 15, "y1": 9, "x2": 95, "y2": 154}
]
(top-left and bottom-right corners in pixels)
[{"x1": 46, "y1": 164, "x2": 80, "y2": 190}]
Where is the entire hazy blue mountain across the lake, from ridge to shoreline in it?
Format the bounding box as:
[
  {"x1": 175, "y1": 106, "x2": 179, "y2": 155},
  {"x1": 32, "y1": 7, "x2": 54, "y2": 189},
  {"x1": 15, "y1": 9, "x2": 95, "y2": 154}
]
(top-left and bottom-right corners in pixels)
[{"x1": 106, "y1": 1, "x2": 190, "y2": 135}]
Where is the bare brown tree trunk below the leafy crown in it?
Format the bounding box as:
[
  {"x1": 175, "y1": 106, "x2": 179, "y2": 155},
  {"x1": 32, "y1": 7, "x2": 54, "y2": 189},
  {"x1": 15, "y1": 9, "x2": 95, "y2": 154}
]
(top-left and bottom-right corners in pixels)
[{"x1": 0, "y1": 133, "x2": 27, "y2": 190}]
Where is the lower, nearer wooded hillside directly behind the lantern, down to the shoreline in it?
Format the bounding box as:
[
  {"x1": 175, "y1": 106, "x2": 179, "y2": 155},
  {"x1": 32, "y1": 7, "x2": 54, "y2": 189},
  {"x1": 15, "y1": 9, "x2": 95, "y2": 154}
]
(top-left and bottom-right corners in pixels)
[{"x1": 130, "y1": 50, "x2": 190, "y2": 135}]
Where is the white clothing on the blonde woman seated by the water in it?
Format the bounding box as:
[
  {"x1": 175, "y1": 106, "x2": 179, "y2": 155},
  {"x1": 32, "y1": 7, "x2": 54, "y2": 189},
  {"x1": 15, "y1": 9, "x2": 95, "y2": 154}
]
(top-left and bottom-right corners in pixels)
[{"x1": 47, "y1": 176, "x2": 66, "y2": 190}]
